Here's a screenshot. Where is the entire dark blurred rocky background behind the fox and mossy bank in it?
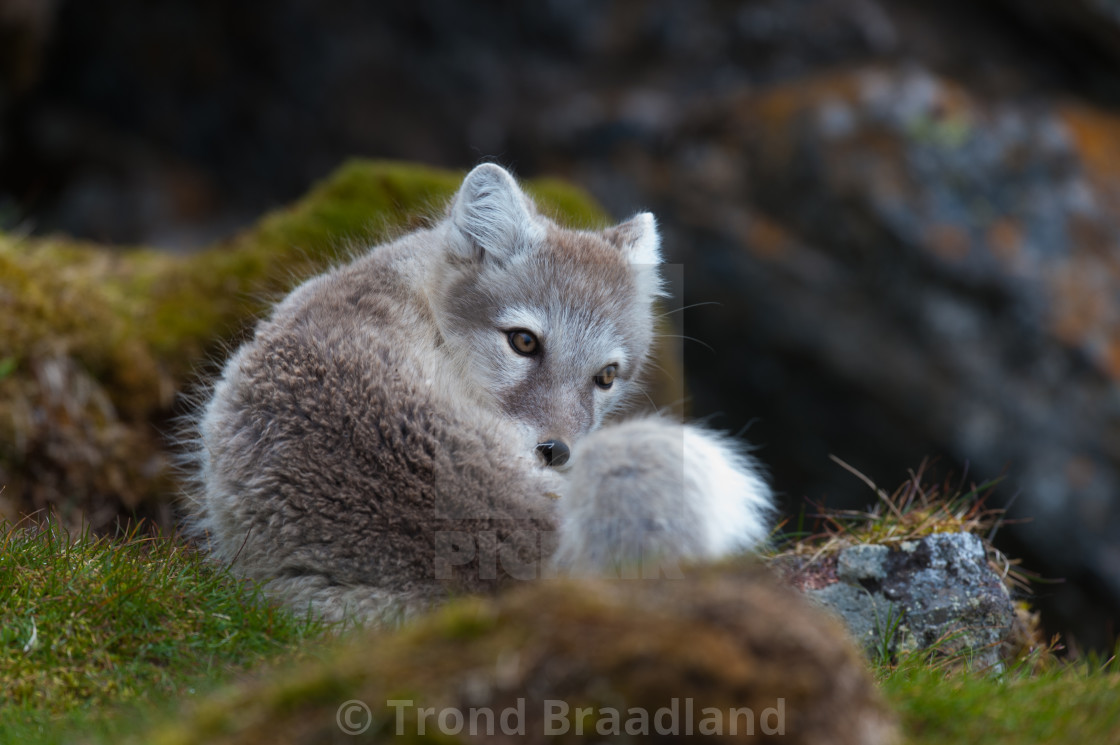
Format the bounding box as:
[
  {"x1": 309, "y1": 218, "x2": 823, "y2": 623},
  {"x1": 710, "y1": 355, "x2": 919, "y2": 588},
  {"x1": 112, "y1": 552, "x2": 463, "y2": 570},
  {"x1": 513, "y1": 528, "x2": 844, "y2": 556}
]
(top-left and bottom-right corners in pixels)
[{"x1": 0, "y1": 0, "x2": 1120, "y2": 646}]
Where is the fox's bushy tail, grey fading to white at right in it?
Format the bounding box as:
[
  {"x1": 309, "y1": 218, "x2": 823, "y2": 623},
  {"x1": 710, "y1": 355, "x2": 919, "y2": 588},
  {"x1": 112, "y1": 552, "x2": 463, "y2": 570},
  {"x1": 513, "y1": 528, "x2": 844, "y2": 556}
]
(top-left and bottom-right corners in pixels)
[{"x1": 554, "y1": 418, "x2": 773, "y2": 576}]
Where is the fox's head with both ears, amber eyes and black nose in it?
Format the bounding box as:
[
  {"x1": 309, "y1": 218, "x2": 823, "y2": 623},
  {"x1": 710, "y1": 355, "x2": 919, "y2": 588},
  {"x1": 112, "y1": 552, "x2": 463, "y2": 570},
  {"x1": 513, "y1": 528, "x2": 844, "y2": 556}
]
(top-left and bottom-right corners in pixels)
[{"x1": 432, "y1": 164, "x2": 662, "y2": 466}]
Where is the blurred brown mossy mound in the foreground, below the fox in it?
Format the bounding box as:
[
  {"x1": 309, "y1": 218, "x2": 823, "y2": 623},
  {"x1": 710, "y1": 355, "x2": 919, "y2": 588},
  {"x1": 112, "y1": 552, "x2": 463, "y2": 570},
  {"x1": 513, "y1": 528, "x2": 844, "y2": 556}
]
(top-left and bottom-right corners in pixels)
[{"x1": 141, "y1": 564, "x2": 895, "y2": 745}]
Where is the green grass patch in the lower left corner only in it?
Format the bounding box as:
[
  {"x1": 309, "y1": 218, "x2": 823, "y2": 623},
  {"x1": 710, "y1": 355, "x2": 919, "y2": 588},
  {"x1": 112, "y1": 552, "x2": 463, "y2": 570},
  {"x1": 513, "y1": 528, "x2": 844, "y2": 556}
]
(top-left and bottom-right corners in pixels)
[{"x1": 0, "y1": 522, "x2": 321, "y2": 743}]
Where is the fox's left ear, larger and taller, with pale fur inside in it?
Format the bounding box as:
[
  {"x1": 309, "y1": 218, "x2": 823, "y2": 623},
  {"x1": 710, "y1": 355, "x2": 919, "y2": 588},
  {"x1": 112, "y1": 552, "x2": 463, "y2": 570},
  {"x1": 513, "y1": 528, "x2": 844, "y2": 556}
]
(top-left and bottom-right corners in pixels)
[{"x1": 451, "y1": 164, "x2": 541, "y2": 261}]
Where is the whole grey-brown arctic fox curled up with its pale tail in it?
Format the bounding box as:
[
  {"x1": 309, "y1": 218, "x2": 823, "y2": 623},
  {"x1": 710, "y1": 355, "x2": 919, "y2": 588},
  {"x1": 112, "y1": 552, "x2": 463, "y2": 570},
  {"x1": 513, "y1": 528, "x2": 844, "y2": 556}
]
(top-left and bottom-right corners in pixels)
[{"x1": 189, "y1": 164, "x2": 772, "y2": 620}]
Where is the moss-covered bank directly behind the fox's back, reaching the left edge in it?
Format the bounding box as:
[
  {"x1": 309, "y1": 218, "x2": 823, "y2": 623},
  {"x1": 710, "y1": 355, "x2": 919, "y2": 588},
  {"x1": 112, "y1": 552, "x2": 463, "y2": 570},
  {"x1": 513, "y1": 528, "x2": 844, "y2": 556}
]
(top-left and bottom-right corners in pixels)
[{"x1": 0, "y1": 161, "x2": 631, "y2": 528}]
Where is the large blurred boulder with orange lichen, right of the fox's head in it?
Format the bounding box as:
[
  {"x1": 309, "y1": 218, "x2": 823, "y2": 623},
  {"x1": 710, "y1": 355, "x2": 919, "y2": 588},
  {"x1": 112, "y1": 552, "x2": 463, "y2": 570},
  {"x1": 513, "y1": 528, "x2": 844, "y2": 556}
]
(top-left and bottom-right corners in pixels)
[{"x1": 659, "y1": 64, "x2": 1120, "y2": 648}]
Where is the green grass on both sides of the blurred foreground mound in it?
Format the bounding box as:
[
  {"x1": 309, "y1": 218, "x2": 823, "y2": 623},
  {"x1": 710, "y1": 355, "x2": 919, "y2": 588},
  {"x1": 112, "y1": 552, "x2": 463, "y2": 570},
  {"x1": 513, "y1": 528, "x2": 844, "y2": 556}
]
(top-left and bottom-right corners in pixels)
[{"x1": 0, "y1": 523, "x2": 1120, "y2": 745}]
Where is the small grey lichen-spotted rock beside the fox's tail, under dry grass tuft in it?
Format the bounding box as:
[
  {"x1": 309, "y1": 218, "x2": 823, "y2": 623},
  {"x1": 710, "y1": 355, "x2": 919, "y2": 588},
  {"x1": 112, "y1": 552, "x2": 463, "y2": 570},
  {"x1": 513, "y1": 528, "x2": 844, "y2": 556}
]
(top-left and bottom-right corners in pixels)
[{"x1": 785, "y1": 533, "x2": 1017, "y2": 669}]
